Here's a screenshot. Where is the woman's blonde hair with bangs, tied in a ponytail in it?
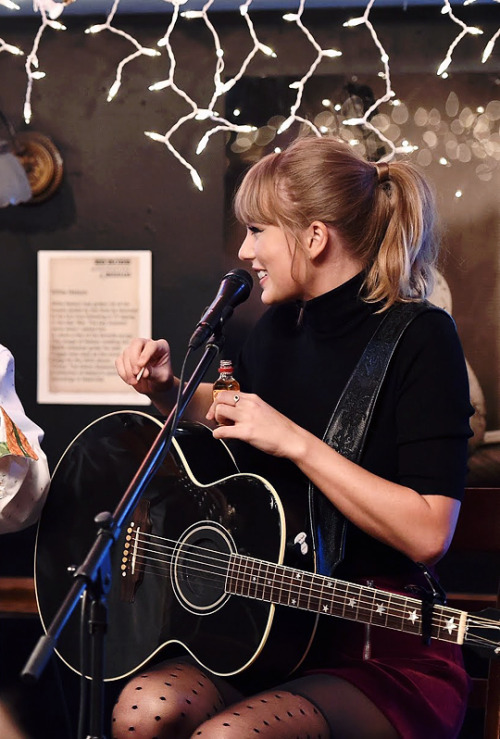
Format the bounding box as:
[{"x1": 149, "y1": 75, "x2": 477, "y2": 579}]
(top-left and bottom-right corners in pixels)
[{"x1": 234, "y1": 136, "x2": 438, "y2": 309}]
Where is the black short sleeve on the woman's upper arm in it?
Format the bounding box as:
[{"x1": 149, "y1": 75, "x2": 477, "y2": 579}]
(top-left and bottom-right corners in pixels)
[{"x1": 396, "y1": 311, "x2": 473, "y2": 499}]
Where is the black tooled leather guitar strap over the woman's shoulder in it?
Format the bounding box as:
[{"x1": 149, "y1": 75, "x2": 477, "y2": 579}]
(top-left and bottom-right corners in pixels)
[{"x1": 309, "y1": 301, "x2": 441, "y2": 576}]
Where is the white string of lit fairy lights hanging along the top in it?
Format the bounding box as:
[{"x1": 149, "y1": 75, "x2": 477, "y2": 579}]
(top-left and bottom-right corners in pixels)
[{"x1": 0, "y1": 0, "x2": 500, "y2": 190}]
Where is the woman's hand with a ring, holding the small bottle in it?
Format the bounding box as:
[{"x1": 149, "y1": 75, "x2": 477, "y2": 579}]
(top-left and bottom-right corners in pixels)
[{"x1": 206, "y1": 390, "x2": 306, "y2": 458}]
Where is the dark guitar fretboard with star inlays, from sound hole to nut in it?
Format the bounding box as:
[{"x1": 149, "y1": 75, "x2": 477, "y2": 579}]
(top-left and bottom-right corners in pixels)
[{"x1": 226, "y1": 554, "x2": 468, "y2": 644}]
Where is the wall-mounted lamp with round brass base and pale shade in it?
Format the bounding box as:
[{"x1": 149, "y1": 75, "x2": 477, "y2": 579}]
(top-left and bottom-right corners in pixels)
[{"x1": 0, "y1": 110, "x2": 63, "y2": 208}]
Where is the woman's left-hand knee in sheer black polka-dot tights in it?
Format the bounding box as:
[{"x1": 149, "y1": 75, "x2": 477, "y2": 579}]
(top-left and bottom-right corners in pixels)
[{"x1": 112, "y1": 662, "x2": 222, "y2": 739}]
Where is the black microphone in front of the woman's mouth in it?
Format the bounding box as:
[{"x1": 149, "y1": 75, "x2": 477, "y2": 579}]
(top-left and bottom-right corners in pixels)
[{"x1": 188, "y1": 269, "x2": 253, "y2": 349}]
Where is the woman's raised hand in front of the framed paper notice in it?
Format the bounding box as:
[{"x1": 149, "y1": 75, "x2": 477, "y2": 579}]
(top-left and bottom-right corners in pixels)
[{"x1": 115, "y1": 339, "x2": 174, "y2": 395}]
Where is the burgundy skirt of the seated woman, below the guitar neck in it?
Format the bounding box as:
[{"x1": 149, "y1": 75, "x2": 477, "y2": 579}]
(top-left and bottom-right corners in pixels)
[{"x1": 304, "y1": 582, "x2": 470, "y2": 739}]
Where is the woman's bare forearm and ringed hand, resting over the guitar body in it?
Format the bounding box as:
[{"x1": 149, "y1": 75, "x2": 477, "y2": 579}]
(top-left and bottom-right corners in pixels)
[{"x1": 208, "y1": 392, "x2": 460, "y2": 564}]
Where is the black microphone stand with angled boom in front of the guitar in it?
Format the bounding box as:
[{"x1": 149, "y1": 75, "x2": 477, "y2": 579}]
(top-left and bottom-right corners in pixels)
[{"x1": 21, "y1": 336, "x2": 223, "y2": 739}]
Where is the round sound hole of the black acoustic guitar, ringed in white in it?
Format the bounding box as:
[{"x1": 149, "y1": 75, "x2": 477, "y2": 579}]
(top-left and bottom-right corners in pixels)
[{"x1": 172, "y1": 521, "x2": 236, "y2": 614}]
